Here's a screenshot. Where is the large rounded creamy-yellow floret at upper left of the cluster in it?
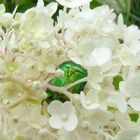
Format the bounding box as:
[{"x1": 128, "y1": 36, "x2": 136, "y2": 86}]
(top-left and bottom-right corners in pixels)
[{"x1": 17, "y1": 10, "x2": 53, "y2": 46}]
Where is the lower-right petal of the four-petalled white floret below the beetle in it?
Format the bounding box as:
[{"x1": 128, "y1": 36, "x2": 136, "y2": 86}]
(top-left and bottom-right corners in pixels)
[{"x1": 64, "y1": 114, "x2": 78, "y2": 131}]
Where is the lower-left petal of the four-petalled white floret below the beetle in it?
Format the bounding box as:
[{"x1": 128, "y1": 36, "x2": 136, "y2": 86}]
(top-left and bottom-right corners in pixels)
[{"x1": 49, "y1": 115, "x2": 64, "y2": 129}]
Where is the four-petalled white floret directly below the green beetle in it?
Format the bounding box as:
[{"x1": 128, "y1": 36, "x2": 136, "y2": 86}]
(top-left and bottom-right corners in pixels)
[{"x1": 48, "y1": 101, "x2": 78, "y2": 131}]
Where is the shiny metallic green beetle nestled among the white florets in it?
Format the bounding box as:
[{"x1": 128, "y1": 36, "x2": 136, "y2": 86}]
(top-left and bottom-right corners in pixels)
[{"x1": 45, "y1": 61, "x2": 88, "y2": 103}]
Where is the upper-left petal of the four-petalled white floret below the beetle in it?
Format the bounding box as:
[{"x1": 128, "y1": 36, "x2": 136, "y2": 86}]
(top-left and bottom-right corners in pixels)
[{"x1": 47, "y1": 100, "x2": 64, "y2": 115}]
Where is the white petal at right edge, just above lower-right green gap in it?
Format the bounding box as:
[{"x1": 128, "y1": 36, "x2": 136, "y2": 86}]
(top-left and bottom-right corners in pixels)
[{"x1": 128, "y1": 97, "x2": 140, "y2": 111}]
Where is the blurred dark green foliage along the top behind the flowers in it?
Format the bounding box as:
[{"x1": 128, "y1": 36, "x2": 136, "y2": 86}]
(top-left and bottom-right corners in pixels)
[{"x1": 0, "y1": 0, "x2": 140, "y2": 27}]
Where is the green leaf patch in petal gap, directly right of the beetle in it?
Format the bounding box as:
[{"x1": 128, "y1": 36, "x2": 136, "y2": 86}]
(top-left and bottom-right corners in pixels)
[{"x1": 112, "y1": 75, "x2": 123, "y2": 90}]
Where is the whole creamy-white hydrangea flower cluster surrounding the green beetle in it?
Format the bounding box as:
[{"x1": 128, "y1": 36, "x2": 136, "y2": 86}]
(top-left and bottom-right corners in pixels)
[{"x1": 0, "y1": 0, "x2": 140, "y2": 140}]
